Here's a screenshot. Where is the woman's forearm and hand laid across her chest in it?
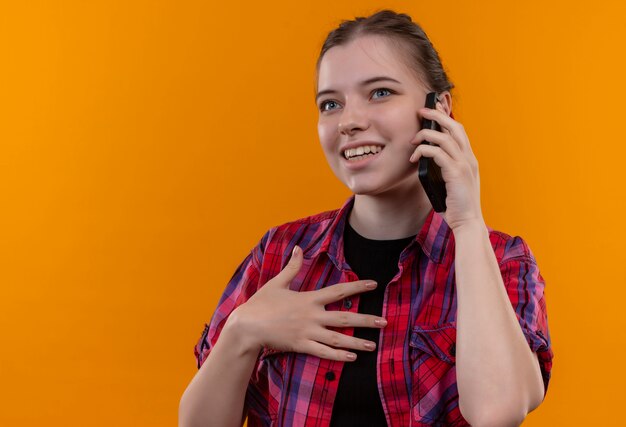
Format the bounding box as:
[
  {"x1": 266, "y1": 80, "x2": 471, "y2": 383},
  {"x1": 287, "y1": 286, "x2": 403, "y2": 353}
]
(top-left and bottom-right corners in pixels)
[{"x1": 179, "y1": 247, "x2": 386, "y2": 427}]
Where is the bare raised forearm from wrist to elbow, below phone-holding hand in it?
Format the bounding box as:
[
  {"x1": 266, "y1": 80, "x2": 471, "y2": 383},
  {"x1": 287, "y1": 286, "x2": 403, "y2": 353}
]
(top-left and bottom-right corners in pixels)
[{"x1": 454, "y1": 221, "x2": 544, "y2": 426}]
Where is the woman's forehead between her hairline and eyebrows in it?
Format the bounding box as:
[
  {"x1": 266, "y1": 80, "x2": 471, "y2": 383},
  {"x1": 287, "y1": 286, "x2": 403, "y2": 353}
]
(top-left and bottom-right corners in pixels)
[{"x1": 318, "y1": 35, "x2": 419, "y2": 90}]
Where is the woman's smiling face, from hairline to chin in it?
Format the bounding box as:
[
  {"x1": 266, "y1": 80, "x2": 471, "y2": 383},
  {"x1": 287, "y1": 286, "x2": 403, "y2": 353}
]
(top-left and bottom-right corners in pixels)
[{"x1": 317, "y1": 35, "x2": 428, "y2": 199}]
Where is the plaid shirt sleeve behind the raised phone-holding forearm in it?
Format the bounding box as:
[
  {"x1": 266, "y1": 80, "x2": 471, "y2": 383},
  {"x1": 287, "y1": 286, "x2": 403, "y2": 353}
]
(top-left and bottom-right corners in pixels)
[{"x1": 500, "y1": 237, "x2": 554, "y2": 393}]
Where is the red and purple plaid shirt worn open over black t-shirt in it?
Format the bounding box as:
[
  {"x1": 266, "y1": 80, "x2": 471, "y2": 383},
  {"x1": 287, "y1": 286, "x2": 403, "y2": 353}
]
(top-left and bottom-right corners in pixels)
[{"x1": 194, "y1": 197, "x2": 552, "y2": 427}]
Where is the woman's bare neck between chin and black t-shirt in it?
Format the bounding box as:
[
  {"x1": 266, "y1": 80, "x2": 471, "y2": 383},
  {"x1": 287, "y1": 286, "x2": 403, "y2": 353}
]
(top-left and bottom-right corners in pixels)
[{"x1": 348, "y1": 185, "x2": 432, "y2": 240}]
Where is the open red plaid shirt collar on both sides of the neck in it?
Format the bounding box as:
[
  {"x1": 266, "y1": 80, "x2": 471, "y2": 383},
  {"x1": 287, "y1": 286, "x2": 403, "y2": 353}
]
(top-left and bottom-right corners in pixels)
[{"x1": 305, "y1": 195, "x2": 453, "y2": 269}]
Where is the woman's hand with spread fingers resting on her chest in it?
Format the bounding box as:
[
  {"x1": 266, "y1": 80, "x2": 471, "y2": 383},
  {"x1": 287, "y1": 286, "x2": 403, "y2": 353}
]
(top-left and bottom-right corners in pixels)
[{"x1": 225, "y1": 246, "x2": 387, "y2": 361}]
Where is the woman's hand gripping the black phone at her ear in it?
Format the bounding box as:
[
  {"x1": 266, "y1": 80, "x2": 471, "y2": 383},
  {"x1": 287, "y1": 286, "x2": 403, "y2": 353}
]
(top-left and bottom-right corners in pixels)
[{"x1": 410, "y1": 103, "x2": 484, "y2": 231}]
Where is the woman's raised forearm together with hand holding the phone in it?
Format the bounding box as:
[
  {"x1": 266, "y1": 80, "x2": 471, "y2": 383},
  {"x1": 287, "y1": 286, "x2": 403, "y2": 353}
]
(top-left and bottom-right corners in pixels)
[{"x1": 410, "y1": 101, "x2": 550, "y2": 426}]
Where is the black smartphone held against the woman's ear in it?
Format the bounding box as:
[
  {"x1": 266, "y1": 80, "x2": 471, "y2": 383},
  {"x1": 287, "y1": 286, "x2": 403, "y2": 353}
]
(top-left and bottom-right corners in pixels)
[{"x1": 418, "y1": 92, "x2": 447, "y2": 212}]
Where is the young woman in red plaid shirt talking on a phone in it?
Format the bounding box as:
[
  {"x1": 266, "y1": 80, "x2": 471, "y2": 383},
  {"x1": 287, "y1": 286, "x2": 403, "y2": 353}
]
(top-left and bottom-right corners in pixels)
[{"x1": 179, "y1": 11, "x2": 552, "y2": 427}]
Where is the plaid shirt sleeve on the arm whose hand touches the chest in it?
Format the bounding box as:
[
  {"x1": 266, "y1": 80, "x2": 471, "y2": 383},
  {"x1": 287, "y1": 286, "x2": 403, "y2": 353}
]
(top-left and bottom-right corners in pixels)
[{"x1": 194, "y1": 232, "x2": 269, "y2": 369}]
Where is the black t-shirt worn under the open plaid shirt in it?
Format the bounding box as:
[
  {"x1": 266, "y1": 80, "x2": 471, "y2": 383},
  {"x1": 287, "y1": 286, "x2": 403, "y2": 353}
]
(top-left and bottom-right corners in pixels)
[{"x1": 330, "y1": 221, "x2": 415, "y2": 427}]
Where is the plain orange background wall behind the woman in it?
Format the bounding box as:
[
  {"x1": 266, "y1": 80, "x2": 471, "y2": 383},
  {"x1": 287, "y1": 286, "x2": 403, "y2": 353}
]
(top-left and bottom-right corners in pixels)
[{"x1": 0, "y1": 0, "x2": 626, "y2": 426}]
